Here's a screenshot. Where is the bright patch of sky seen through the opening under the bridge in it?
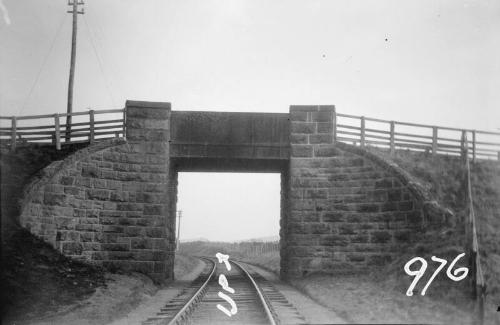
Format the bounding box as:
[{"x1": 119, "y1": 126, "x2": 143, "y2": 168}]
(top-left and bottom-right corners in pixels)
[{"x1": 177, "y1": 173, "x2": 280, "y2": 241}]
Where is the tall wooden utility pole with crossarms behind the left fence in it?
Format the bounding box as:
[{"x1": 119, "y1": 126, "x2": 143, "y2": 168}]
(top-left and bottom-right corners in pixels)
[{"x1": 65, "y1": 0, "x2": 85, "y2": 142}]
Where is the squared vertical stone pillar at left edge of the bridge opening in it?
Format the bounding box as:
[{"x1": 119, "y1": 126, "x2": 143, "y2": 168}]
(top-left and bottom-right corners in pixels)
[{"x1": 123, "y1": 101, "x2": 176, "y2": 281}]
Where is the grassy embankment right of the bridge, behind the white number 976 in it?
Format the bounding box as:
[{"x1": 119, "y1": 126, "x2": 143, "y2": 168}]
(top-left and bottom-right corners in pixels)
[{"x1": 293, "y1": 150, "x2": 500, "y2": 324}]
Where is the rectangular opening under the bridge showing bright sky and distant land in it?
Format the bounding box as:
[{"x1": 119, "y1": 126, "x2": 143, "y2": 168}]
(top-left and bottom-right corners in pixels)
[{"x1": 174, "y1": 170, "x2": 284, "y2": 278}]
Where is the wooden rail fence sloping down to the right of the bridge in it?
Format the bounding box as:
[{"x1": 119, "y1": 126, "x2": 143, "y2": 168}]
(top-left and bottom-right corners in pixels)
[{"x1": 333, "y1": 113, "x2": 500, "y2": 161}]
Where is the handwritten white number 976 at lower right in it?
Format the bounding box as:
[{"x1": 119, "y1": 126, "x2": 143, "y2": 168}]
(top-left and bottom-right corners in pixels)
[{"x1": 404, "y1": 253, "x2": 469, "y2": 296}]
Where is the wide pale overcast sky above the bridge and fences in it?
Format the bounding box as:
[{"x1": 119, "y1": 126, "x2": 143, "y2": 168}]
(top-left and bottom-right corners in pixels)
[{"x1": 0, "y1": 0, "x2": 500, "y2": 237}]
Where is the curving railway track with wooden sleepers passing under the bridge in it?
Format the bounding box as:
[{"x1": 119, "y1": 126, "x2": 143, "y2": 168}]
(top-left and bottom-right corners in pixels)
[{"x1": 143, "y1": 258, "x2": 305, "y2": 325}]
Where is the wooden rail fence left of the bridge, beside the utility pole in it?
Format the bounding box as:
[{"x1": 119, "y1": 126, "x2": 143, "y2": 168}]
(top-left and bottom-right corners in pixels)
[{"x1": 0, "y1": 109, "x2": 125, "y2": 150}]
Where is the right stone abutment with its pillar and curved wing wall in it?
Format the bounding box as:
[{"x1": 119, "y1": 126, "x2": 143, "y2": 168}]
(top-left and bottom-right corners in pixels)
[{"x1": 281, "y1": 106, "x2": 446, "y2": 278}]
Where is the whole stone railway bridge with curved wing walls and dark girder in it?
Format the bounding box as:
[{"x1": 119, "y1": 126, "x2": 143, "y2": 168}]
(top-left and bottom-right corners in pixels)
[{"x1": 7, "y1": 101, "x2": 450, "y2": 282}]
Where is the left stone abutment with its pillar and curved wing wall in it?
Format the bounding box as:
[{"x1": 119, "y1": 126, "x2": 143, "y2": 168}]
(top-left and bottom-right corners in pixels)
[{"x1": 20, "y1": 102, "x2": 175, "y2": 281}]
